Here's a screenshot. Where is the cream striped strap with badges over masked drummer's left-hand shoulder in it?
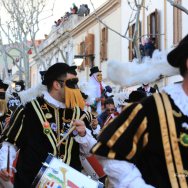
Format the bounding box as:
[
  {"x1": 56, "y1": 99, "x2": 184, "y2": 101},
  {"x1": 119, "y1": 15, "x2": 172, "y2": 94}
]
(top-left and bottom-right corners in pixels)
[{"x1": 31, "y1": 100, "x2": 57, "y2": 156}]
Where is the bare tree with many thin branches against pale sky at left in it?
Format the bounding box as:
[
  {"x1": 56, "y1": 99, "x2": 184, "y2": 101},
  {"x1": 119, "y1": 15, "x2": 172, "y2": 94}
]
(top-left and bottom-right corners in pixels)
[{"x1": 0, "y1": 0, "x2": 53, "y2": 87}]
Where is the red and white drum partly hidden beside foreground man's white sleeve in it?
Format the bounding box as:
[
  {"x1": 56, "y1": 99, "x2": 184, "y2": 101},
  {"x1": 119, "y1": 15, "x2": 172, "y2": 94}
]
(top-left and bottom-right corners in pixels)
[{"x1": 80, "y1": 155, "x2": 106, "y2": 180}]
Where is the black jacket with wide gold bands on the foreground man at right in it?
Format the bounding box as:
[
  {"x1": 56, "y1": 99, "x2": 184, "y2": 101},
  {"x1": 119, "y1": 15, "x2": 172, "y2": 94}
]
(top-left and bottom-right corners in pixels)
[{"x1": 92, "y1": 94, "x2": 188, "y2": 188}]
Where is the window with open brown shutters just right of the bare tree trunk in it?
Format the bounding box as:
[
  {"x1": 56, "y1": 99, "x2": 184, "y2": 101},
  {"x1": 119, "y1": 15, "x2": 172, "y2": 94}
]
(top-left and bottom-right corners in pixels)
[{"x1": 147, "y1": 9, "x2": 160, "y2": 49}]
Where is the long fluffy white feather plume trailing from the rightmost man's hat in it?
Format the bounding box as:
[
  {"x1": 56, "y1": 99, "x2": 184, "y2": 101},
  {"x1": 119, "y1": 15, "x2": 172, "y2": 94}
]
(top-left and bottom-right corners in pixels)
[{"x1": 107, "y1": 50, "x2": 179, "y2": 87}]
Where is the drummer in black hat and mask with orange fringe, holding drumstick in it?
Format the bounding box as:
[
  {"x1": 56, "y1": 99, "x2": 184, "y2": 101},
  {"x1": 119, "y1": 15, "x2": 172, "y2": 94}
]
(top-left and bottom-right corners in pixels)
[{"x1": 0, "y1": 63, "x2": 96, "y2": 188}]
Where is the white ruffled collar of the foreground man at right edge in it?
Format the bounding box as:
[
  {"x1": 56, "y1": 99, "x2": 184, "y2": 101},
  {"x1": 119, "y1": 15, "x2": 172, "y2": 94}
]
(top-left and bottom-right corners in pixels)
[{"x1": 163, "y1": 84, "x2": 188, "y2": 116}]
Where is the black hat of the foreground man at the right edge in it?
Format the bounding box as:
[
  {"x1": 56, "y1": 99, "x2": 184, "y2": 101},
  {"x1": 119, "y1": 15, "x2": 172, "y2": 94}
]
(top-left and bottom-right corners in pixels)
[{"x1": 167, "y1": 35, "x2": 188, "y2": 67}]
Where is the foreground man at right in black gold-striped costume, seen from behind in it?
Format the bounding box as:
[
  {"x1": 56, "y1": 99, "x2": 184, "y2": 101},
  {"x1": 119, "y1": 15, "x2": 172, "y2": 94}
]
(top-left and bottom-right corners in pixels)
[{"x1": 92, "y1": 35, "x2": 188, "y2": 188}]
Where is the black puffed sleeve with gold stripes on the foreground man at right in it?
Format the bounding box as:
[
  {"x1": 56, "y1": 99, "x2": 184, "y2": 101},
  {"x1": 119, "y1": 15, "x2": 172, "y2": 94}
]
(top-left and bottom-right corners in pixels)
[{"x1": 92, "y1": 103, "x2": 148, "y2": 161}]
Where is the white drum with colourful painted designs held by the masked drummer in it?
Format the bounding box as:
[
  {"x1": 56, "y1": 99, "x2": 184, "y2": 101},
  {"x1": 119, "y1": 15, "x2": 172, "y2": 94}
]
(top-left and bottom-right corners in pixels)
[{"x1": 32, "y1": 154, "x2": 99, "y2": 188}]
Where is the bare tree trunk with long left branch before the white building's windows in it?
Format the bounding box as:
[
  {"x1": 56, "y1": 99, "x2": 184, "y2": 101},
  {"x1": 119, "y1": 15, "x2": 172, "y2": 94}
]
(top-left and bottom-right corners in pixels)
[{"x1": 90, "y1": 0, "x2": 147, "y2": 63}]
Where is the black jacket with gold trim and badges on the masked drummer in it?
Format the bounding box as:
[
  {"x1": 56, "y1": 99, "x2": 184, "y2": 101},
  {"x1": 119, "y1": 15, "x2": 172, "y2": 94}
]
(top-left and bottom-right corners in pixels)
[{"x1": 1, "y1": 97, "x2": 94, "y2": 187}]
